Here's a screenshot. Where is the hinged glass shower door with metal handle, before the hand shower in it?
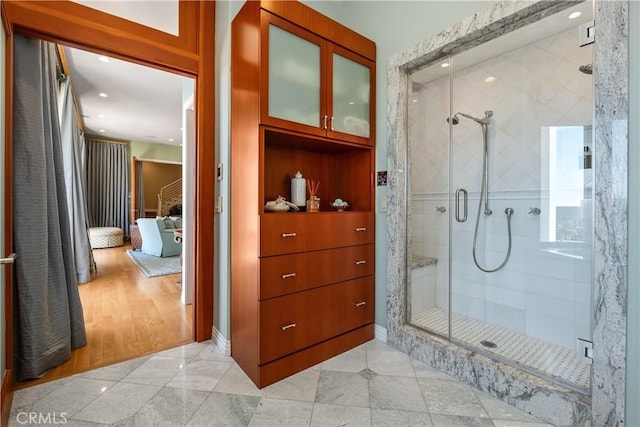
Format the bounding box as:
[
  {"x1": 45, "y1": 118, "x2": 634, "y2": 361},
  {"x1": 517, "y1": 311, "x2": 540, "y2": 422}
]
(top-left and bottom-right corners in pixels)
[{"x1": 450, "y1": 5, "x2": 593, "y2": 389}]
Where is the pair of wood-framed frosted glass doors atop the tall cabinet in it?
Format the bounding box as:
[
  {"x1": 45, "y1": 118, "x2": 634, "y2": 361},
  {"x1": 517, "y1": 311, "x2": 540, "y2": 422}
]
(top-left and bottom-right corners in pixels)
[{"x1": 260, "y1": 10, "x2": 375, "y2": 144}]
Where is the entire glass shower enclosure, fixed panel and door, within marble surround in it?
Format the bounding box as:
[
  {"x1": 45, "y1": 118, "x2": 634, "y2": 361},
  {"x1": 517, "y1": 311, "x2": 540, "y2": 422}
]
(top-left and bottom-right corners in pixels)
[{"x1": 406, "y1": 2, "x2": 597, "y2": 392}]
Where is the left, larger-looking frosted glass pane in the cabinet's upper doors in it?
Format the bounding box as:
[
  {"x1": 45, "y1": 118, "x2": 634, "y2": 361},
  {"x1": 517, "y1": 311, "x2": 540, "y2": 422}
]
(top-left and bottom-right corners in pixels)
[{"x1": 268, "y1": 24, "x2": 324, "y2": 129}]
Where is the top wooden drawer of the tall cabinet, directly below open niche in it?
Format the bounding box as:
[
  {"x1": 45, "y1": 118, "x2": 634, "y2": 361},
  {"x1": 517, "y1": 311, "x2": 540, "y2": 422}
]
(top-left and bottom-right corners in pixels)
[{"x1": 260, "y1": 212, "x2": 375, "y2": 257}]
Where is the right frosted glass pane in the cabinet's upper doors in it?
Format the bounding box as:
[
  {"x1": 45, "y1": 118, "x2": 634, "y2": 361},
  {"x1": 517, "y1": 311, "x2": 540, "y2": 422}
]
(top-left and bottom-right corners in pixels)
[{"x1": 331, "y1": 51, "x2": 371, "y2": 138}]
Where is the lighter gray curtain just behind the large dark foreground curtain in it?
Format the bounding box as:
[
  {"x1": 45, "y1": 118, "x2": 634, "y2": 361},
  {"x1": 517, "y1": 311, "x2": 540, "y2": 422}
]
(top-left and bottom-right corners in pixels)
[{"x1": 58, "y1": 77, "x2": 94, "y2": 283}]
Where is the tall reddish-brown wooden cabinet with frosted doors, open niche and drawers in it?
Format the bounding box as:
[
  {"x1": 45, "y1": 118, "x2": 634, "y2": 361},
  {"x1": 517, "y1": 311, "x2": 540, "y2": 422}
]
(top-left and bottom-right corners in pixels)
[{"x1": 231, "y1": 1, "x2": 375, "y2": 387}]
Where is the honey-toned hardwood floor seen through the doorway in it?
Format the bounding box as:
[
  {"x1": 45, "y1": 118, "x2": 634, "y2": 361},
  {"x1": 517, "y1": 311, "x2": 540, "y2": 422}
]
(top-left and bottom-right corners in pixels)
[{"x1": 15, "y1": 244, "x2": 193, "y2": 389}]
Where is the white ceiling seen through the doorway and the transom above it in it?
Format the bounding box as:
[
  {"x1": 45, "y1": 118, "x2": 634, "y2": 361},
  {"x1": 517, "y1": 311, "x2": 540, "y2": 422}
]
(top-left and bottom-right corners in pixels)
[{"x1": 64, "y1": 0, "x2": 193, "y2": 145}]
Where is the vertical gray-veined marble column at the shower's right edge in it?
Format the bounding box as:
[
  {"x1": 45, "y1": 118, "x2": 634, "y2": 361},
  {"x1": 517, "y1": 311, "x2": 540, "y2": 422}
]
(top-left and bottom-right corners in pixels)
[{"x1": 592, "y1": 0, "x2": 629, "y2": 426}]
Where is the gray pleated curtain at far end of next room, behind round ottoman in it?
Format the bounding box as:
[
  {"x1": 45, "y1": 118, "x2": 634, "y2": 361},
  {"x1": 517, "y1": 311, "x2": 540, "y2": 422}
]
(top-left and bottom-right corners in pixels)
[{"x1": 86, "y1": 138, "x2": 129, "y2": 236}]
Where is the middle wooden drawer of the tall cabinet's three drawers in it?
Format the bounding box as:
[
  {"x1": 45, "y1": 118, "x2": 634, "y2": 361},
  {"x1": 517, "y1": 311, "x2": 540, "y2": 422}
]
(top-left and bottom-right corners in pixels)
[{"x1": 260, "y1": 244, "x2": 375, "y2": 300}]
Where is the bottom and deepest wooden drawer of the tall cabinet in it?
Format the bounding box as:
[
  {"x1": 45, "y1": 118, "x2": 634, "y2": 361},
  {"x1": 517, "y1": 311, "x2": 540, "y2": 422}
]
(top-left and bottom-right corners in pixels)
[{"x1": 259, "y1": 276, "x2": 374, "y2": 364}]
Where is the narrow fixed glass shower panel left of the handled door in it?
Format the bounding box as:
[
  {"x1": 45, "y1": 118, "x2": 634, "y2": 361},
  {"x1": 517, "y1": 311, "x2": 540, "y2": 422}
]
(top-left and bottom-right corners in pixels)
[{"x1": 407, "y1": 60, "x2": 450, "y2": 337}]
